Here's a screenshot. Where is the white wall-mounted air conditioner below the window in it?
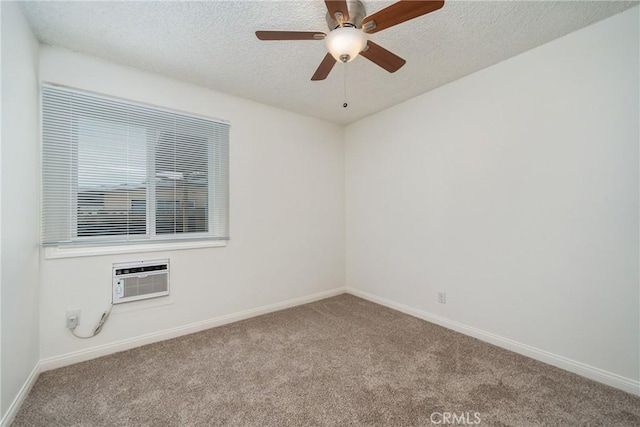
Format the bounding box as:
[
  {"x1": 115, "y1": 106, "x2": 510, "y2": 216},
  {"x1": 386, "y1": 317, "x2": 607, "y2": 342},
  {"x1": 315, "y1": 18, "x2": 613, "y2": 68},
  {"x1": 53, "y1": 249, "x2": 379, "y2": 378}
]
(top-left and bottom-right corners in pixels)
[{"x1": 113, "y1": 259, "x2": 169, "y2": 304}]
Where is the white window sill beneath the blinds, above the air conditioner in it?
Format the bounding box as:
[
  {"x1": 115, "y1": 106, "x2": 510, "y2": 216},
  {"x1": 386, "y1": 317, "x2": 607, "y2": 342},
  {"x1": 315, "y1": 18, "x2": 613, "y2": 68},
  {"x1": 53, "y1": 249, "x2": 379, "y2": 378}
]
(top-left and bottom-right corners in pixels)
[{"x1": 44, "y1": 240, "x2": 227, "y2": 259}]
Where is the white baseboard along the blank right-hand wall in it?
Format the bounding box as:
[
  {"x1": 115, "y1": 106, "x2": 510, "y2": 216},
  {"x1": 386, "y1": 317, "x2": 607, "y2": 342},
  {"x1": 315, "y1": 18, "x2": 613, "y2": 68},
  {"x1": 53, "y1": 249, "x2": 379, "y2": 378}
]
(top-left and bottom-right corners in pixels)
[{"x1": 347, "y1": 286, "x2": 640, "y2": 396}]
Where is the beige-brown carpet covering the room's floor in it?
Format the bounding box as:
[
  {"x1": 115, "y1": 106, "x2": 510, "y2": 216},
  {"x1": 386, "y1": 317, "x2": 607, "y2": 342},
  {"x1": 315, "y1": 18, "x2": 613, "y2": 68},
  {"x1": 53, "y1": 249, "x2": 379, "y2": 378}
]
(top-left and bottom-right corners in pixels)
[{"x1": 14, "y1": 295, "x2": 640, "y2": 426}]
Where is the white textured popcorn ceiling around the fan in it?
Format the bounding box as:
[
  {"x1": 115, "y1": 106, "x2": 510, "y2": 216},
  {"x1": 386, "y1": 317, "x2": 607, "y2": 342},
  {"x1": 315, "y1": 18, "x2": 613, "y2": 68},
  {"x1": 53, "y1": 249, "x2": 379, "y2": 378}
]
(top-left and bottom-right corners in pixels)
[{"x1": 22, "y1": 0, "x2": 638, "y2": 124}]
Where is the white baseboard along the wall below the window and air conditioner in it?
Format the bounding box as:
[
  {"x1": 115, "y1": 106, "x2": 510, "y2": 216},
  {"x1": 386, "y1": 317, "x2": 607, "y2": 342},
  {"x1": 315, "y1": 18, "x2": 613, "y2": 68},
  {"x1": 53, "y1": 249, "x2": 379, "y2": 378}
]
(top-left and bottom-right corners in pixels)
[{"x1": 40, "y1": 287, "x2": 345, "y2": 372}]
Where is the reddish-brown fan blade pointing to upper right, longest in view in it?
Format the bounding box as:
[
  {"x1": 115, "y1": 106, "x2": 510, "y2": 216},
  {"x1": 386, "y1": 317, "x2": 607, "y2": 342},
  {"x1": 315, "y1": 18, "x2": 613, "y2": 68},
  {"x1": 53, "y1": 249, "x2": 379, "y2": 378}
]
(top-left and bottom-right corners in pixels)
[{"x1": 362, "y1": 0, "x2": 444, "y2": 34}]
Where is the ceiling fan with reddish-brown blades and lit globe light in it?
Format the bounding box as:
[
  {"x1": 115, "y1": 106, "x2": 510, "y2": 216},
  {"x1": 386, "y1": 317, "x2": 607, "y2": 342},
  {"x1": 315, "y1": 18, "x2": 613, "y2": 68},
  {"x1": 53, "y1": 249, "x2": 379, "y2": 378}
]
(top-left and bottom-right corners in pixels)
[{"x1": 256, "y1": 0, "x2": 444, "y2": 80}]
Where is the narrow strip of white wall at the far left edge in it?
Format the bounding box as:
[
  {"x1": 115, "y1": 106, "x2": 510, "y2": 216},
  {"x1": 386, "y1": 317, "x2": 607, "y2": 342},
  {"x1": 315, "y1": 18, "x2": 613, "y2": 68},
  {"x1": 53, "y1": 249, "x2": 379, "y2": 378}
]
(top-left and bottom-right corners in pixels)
[{"x1": 0, "y1": 2, "x2": 40, "y2": 418}]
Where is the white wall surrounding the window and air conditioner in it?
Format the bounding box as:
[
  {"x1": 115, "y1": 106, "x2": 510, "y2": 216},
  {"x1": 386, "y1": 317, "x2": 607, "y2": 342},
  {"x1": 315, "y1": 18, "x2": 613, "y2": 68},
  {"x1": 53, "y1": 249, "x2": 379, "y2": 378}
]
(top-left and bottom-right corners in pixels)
[{"x1": 34, "y1": 46, "x2": 345, "y2": 368}]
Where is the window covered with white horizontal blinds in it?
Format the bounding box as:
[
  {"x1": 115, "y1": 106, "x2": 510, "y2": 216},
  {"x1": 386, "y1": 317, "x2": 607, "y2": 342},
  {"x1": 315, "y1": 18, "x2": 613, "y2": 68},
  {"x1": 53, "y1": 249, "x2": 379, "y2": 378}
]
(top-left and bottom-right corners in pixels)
[{"x1": 42, "y1": 85, "x2": 229, "y2": 245}]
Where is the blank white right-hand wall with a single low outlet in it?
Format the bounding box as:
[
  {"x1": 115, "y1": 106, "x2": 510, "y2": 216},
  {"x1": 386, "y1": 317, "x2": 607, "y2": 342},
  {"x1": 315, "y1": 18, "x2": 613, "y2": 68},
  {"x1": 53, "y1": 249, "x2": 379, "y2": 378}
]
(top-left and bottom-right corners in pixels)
[{"x1": 345, "y1": 7, "x2": 640, "y2": 390}]
